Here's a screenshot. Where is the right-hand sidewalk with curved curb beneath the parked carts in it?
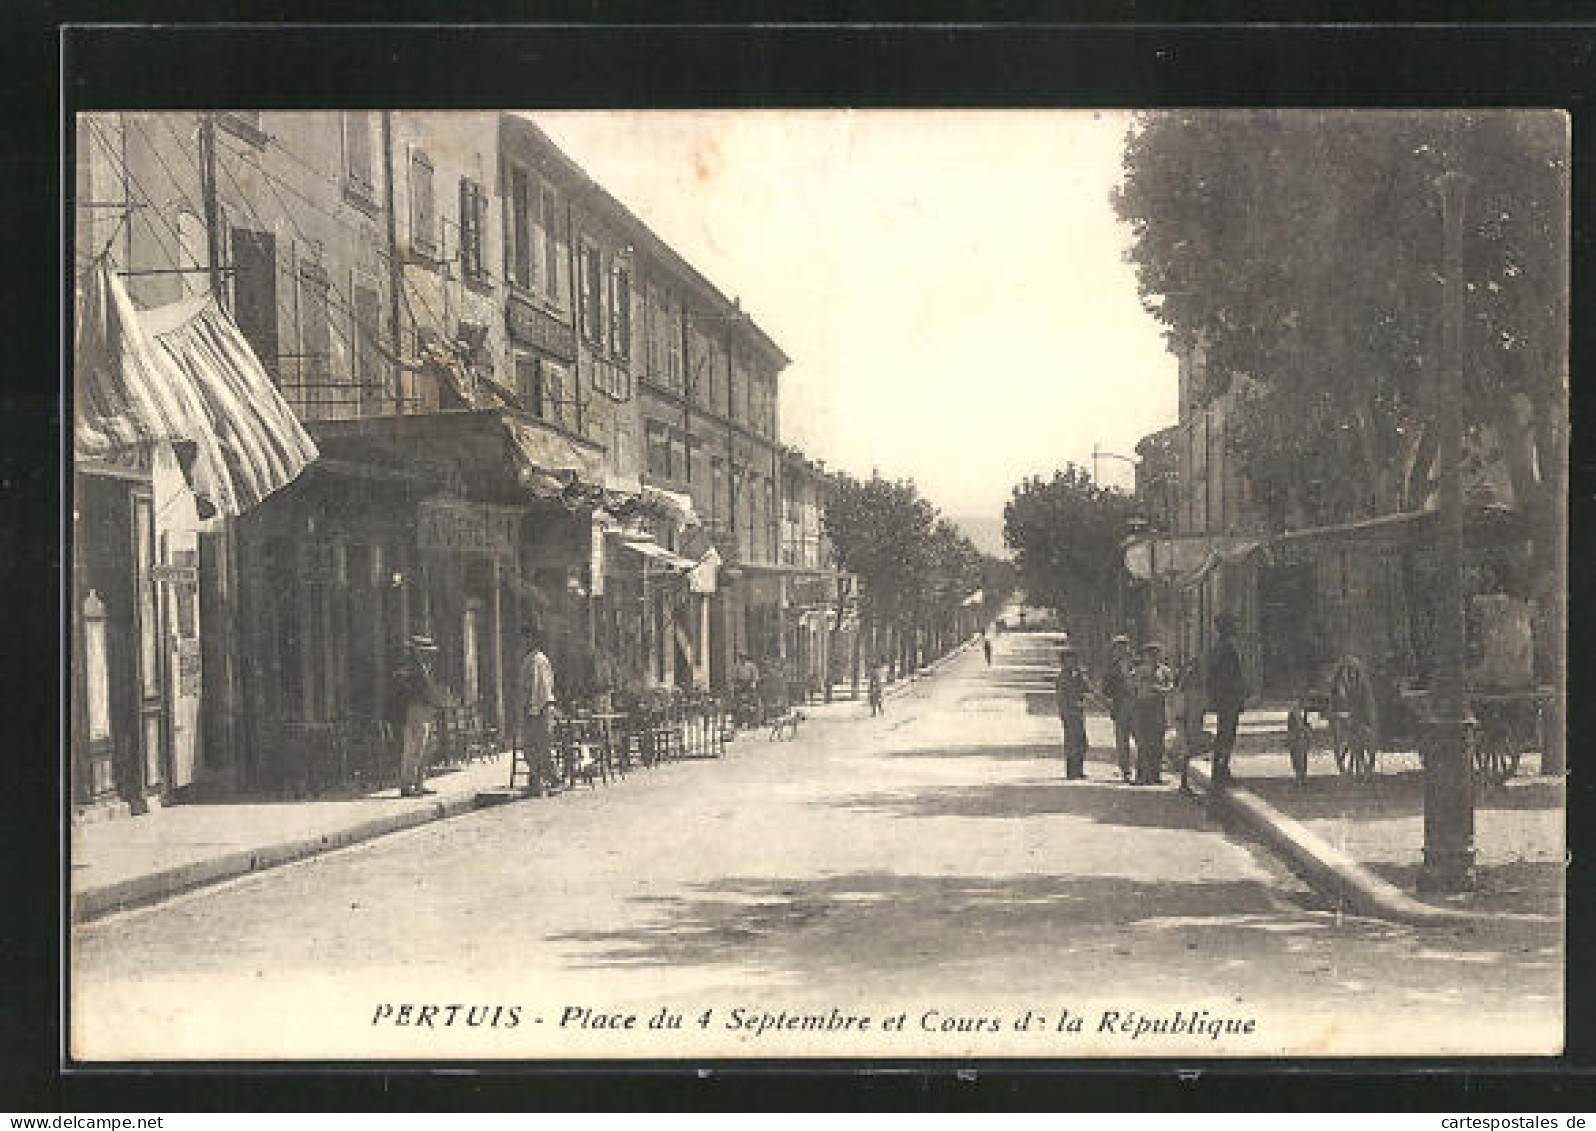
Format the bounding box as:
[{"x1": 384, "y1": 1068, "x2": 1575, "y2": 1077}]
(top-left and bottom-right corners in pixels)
[{"x1": 1192, "y1": 715, "x2": 1564, "y2": 924}]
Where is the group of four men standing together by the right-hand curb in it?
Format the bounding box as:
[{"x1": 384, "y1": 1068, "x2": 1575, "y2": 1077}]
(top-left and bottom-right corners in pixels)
[{"x1": 1053, "y1": 613, "x2": 1248, "y2": 790}]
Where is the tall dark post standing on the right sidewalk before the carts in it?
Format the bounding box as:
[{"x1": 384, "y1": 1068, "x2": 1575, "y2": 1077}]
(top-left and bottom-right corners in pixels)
[{"x1": 1419, "y1": 172, "x2": 1475, "y2": 892}]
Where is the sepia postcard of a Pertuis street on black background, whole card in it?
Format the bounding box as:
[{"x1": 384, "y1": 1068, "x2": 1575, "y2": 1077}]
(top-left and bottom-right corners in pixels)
[{"x1": 64, "y1": 107, "x2": 1569, "y2": 1064}]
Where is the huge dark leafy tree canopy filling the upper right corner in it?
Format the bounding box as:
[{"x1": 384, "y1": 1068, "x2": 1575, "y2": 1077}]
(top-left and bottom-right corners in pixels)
[{"x1": 1114, "y1": 110, "x2": 1569, "y2": 539}]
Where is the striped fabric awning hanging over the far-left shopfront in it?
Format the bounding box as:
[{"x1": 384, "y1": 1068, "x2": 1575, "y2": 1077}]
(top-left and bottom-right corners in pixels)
[{"x1": 73, "y1": 260, "x2": 316, "y2": 515}]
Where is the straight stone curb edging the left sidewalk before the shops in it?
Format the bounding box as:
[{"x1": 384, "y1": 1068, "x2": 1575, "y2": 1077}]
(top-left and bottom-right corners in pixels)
[{"x1": 72, "y1": 793, "x2": 477, "y2": 924}]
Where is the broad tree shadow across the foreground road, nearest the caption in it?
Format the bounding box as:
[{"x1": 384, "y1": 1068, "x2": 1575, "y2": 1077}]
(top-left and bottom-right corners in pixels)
[{"x1": 549, "y1": 871, "x2": 1561, "y2": 987}]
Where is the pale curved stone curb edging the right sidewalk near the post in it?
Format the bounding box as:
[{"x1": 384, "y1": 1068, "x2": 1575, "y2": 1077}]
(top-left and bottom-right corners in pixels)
[{"x1": 1189, "y1": 763, "x2": 1481, "y2": 927}]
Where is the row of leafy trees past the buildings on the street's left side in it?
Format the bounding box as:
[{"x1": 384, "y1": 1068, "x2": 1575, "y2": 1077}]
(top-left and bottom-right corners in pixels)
[{"x1": 822, "y1": 472, "x2": 1007, "y2": 678}]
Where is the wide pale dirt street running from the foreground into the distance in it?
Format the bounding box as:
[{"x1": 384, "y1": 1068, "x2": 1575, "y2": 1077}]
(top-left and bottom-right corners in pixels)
[{"x1": 72, "y1": 633, "x2": 1562, "y2": 1058}]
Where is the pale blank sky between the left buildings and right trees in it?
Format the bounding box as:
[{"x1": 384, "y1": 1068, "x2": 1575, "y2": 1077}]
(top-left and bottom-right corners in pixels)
[{"x1": 530, "y1": 110, "x2": 1176, "y2": 550}]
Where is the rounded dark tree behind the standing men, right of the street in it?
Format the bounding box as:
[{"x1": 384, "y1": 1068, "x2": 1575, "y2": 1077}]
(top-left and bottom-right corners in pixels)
[{"x1": 1002, "y1": 463, "x2": 1136, "y2": 634}]
